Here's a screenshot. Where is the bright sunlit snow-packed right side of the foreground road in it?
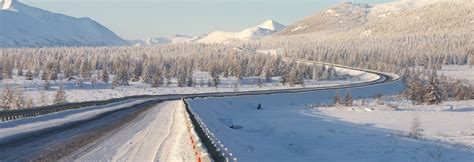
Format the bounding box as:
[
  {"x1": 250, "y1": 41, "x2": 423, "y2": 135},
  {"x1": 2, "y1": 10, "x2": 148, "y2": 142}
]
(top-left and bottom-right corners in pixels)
[{"x1": 68, "y1": 101, "x2": 196, "y2": 162}]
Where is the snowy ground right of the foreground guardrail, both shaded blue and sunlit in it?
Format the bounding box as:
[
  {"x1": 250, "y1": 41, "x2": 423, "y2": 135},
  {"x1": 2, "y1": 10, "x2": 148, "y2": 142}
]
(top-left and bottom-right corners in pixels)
[{"x1": 189, "y1": 80, "x2": 474, "y2": 162}]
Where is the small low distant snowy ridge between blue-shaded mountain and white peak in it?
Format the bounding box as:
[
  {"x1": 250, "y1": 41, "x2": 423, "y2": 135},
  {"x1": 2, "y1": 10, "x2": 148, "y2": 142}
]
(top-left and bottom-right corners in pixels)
[{"x1": 129, "y1": 34, "x2": 202, "y2": 46}]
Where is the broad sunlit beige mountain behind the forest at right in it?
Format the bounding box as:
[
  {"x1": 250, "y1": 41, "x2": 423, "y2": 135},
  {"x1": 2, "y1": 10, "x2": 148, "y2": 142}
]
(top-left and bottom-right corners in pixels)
[{"x1": 276, "y1": 0, "x2": 474, "y2": 36}]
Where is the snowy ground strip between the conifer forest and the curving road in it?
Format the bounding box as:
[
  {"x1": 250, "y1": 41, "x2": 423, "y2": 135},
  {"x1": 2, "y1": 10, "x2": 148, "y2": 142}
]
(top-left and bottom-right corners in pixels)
[{"x1": 0, "y1": 70, "x2": 374, "y2": 105}]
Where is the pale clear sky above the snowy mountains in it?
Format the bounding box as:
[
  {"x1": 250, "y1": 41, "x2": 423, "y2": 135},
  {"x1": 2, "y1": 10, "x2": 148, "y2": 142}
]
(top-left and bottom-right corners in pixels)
[{"x1": 19, "y1": 0, "x2": 393, "y2": 39}]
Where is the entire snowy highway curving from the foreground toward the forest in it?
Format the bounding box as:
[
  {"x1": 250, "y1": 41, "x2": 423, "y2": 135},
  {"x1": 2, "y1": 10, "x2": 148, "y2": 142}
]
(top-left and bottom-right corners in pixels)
[{"x1": 0, "y1": 58, "x2": 400, "y2": 161}]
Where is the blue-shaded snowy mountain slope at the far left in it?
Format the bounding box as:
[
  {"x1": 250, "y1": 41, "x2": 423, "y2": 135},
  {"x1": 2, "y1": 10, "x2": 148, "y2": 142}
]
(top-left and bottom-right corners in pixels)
[{"x1": 0, "y1": 0, "x2": 128, "y2": 48}]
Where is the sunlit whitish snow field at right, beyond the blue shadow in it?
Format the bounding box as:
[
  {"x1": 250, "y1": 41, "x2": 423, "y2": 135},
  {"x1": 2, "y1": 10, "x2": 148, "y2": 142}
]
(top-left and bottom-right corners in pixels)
[{"x1": 311, "y1": 100, "x2": 474, "y2": 148}]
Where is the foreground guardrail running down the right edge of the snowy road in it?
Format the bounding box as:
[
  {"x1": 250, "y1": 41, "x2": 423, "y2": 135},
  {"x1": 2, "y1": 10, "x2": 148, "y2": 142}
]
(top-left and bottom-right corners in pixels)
[{"x1": 181, "y1": 97, "x2": 237, "y2": 162}]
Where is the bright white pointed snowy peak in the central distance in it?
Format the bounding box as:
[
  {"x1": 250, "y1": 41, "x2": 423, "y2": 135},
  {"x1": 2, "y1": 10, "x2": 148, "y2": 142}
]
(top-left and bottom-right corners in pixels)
[{"x1": 198, "y1": 20, "x2": 285, "y2": 43}]
